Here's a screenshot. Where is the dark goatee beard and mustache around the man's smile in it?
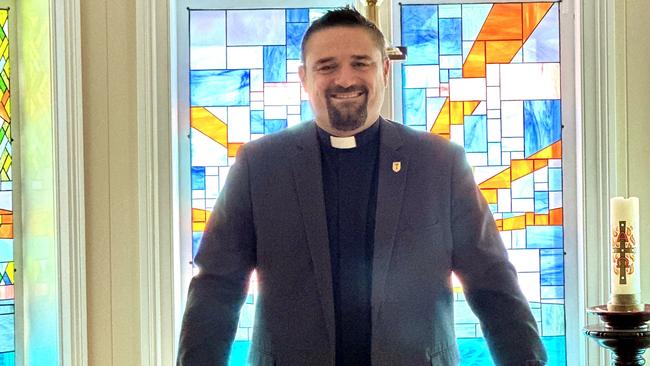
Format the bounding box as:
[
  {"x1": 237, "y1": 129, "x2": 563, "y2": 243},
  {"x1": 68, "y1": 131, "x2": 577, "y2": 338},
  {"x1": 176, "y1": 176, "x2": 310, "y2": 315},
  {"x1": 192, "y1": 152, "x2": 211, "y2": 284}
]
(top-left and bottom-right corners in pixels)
[{"x1": 326, "y1": 86, "x2": 368, "y2": 131}]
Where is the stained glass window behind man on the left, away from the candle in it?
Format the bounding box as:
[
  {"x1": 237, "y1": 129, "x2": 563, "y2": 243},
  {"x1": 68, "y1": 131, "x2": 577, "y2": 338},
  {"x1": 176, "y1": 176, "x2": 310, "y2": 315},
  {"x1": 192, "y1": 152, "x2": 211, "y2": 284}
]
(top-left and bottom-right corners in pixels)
[{"x1": 189, "y1": 2, "x2": 345, "y2": 365}]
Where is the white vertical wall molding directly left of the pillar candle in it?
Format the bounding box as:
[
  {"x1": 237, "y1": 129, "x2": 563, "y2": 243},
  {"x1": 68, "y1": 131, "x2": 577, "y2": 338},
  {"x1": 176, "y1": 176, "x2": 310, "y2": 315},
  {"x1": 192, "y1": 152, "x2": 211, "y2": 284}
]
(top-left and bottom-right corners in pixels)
[{"x1": 576, "y1": 0, "x2": 621, "y2": 365}]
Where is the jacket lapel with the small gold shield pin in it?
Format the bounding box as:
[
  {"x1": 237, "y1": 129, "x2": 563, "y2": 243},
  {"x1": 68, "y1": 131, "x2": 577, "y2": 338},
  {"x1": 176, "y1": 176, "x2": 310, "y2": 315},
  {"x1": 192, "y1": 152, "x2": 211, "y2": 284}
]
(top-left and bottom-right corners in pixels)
[{"x1": 371, "y1": 119, "x2": 408, "y2": 322}]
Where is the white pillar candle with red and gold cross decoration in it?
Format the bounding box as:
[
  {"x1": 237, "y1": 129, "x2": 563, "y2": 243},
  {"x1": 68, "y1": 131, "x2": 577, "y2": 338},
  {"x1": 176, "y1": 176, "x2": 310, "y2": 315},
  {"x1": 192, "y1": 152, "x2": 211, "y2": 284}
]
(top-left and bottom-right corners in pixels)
[{"x1": 610, "y1": 197, "x2": 641, "y2": 296}]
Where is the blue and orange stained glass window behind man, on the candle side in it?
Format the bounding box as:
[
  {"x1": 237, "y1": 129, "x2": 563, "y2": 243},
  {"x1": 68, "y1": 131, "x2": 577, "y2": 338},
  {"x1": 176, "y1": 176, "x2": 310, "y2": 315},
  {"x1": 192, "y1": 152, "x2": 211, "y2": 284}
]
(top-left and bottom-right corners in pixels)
[{"x1": 396, "y1": 2, "x2": 566, "y2": 365}]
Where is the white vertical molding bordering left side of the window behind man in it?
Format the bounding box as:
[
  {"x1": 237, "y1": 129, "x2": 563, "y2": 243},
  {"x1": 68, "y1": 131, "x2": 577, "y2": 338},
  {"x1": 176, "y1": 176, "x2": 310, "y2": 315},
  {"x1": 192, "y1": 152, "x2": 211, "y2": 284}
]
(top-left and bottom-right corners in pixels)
[{"x1": 136, "y1": 0, "x2": 175, "y2": 366}]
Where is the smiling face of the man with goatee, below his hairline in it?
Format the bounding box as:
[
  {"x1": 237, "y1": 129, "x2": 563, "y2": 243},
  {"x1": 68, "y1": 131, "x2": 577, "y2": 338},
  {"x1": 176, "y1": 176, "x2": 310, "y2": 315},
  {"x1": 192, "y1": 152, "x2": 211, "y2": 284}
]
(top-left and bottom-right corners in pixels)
[{"x1": 299, "y1": 26, "x2": 389, "y2": 136}]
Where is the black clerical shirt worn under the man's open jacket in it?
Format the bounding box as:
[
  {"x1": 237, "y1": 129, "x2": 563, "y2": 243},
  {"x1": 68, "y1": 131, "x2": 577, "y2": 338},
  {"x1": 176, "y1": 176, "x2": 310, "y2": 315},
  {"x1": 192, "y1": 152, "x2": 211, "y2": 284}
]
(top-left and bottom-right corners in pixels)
[{"x1": 319, "y1": 123, "x2": 379, "y2": 366}]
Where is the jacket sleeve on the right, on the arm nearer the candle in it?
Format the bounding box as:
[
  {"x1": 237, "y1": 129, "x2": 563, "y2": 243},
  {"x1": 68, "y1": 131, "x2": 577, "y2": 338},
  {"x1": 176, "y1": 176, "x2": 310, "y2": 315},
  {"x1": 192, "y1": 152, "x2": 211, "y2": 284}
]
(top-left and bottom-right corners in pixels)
[{"x1": 451, "y1": 144, "x2": 547, "y2": 366}]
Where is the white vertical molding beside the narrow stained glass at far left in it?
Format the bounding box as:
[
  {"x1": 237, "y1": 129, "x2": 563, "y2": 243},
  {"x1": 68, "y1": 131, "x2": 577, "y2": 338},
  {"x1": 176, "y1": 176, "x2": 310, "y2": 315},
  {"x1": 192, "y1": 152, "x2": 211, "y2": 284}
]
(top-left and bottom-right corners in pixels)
[{"x1": 50, "y1": 0, "x2": 88, "y2": 366}]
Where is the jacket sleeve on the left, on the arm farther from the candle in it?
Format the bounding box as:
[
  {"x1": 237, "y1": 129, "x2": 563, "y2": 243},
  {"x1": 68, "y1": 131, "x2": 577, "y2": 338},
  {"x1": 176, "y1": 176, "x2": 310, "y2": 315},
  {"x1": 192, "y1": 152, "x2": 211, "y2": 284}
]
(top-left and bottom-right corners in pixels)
[{"x1": 177, "y1": 148, "x2": 256, "y2": 366}]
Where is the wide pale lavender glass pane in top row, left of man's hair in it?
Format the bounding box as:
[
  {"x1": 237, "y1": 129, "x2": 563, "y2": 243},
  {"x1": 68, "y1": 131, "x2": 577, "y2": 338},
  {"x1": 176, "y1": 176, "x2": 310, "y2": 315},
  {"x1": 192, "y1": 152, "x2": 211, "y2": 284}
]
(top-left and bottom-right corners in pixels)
[{"x1": 226, "y1": 9, "x2": 286, "y2": 46}]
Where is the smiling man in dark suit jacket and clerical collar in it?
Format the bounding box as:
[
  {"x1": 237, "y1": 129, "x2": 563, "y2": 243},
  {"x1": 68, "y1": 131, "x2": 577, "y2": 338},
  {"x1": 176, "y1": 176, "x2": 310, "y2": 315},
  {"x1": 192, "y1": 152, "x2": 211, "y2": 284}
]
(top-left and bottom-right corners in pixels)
[{"x1": 178, "y1": 8, "x2": 546, "y2": 366}]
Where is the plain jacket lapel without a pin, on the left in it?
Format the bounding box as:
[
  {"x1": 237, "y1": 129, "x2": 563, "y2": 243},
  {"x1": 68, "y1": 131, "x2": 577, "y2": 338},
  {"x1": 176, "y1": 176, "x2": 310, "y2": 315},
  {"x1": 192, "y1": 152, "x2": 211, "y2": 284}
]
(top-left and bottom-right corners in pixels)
[{"x1": 292, "y1": 122, "x2": 335, "y2": 346}]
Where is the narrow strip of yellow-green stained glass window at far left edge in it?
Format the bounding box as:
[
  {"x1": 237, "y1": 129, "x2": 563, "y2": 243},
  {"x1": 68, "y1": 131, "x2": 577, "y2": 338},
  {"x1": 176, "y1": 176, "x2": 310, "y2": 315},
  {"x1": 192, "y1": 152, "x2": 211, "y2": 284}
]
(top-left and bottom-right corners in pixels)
[{"x1": 0, "y1": 9, "x2": 16, "y2": 366}]
